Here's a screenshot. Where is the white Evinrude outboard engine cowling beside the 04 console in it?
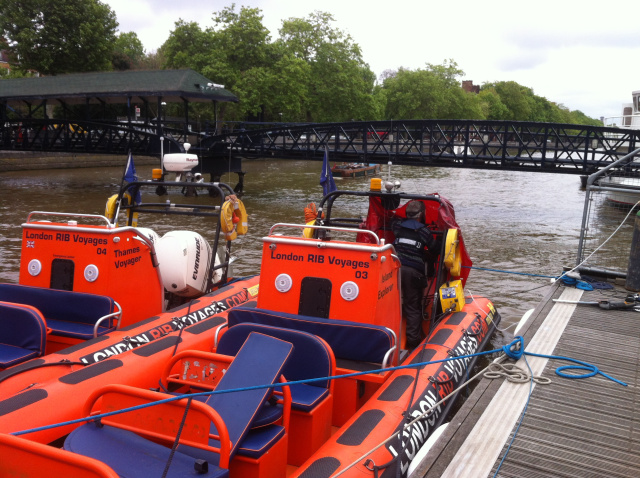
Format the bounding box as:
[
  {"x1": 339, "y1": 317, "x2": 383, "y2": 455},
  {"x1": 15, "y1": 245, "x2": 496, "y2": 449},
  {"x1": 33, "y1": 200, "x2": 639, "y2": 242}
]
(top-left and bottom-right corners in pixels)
[{"x1": 156, "y1": 231, "x2": 211, "y2": 297}]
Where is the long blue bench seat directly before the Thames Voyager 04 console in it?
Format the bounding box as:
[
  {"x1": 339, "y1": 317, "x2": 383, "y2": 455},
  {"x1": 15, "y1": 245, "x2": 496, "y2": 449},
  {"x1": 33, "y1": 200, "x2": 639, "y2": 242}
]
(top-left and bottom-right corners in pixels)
[{"x1": 0, "y1": 284, "x2": 122, "y2": 340}]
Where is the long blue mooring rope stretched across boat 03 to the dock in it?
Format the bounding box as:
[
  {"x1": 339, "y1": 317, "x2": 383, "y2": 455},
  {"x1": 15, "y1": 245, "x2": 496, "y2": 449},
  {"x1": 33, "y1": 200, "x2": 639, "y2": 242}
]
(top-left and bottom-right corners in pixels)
[{"x1": 10, "y1": 336, "x2": 627, "y2": 437}]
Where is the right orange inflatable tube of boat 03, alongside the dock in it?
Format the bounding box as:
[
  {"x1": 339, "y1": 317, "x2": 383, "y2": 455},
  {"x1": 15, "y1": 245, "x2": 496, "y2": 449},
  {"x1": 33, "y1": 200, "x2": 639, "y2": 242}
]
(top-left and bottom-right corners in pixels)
[{"x1": 294, "y1": 297, "x2": 500, "y2": 478}]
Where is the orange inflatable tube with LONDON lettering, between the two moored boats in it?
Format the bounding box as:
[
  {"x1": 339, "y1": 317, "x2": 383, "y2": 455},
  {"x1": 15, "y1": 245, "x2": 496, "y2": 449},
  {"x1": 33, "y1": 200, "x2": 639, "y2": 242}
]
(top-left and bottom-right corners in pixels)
[{"x1": 0, "y1": 276, "x2": 259, "y2": 443}]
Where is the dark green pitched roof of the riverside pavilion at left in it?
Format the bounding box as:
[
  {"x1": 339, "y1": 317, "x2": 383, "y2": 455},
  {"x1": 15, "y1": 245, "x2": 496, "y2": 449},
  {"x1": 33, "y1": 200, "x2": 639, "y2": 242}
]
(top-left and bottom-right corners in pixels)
[{"x1": 0, "y1": 69, "x2": 238, "y2": 105}]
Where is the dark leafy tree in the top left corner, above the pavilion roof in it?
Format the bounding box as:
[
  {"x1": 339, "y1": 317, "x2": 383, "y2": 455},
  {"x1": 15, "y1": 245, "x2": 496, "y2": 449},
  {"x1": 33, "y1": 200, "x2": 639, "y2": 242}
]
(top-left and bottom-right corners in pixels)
[{"x1": 0, "y1": 0, "x2": 118, "y2": 75}]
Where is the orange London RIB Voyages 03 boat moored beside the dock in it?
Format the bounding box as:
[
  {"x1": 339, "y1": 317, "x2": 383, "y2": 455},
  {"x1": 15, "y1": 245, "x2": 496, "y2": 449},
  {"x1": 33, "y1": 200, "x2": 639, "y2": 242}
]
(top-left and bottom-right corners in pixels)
[{"x1": 0, "y1": 170, "x2": 500, "y2": 478}]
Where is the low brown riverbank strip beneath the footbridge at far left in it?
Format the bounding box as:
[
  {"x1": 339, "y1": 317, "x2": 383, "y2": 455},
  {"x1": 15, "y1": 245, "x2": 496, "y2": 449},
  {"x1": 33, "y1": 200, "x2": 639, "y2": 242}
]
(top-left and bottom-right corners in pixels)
[{"x1": 0, "y1": 150, "x2": 160, "y2": 173}]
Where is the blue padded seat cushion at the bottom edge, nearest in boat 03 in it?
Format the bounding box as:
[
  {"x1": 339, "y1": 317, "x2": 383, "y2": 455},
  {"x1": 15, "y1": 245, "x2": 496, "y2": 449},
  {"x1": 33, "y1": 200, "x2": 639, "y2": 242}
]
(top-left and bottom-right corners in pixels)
[{"x1": 64, "y1": 423, "x2": 229, "y2": 478}]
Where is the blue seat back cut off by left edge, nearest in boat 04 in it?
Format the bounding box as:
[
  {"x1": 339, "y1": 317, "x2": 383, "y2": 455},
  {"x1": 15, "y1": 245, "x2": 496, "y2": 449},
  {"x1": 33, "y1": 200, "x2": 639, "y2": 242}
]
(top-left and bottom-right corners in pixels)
[{"x1": 0, "y1": 302, "x2": 47, "y2": 368}]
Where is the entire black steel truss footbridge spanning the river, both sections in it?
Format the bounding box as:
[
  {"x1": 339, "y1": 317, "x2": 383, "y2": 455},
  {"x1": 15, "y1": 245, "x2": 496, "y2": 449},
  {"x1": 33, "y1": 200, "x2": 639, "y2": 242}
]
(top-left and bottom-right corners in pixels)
[{"x1": 0, "y1": 118, "x2": 640, "y2": 174}]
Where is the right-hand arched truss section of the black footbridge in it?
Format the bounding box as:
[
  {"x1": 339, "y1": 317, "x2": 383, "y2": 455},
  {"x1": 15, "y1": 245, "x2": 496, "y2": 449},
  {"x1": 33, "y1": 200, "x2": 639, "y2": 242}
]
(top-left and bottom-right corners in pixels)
[{"x1": 217, "y1": 120, "x2": 640, "y2": 174}]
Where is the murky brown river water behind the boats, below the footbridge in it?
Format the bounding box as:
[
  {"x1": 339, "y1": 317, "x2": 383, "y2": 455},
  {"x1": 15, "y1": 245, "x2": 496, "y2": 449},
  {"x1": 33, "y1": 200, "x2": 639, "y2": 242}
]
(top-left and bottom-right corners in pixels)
[{"x1": 0, "y1": 159, "x2": 585, "y2": 334}]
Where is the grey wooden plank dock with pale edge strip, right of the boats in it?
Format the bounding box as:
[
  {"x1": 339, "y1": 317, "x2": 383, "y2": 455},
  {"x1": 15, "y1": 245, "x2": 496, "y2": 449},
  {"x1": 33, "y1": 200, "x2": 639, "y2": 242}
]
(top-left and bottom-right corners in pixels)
[{"x1": 413, "y1": 287, "x2": 640, "y2": 478}]
